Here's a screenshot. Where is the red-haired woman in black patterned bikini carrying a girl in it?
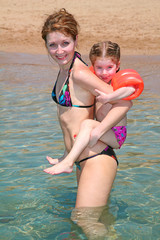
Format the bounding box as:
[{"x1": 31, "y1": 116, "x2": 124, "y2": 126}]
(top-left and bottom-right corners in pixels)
[{"x1": 42, "y1": 9, "x2": 132, "y2": 228}]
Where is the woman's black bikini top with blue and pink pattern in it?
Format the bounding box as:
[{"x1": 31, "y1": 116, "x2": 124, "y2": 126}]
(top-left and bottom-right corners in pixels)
[{"x1": 52, "y1": 52, "x2": 94, "y2": 108}]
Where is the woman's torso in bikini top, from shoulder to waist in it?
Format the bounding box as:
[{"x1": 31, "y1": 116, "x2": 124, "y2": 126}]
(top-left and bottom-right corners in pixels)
[{"x1": 52, "y1": 52, "x2": 94, "y2": 151}]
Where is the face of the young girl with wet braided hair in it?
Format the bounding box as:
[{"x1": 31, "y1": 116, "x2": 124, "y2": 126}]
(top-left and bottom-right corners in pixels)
[{"x1": 93, "y1": 57, "x2": 120, "y2": 84}]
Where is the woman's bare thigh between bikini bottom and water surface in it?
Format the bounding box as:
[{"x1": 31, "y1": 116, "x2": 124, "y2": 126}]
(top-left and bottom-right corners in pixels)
[{"x1": 76, "y1": 155, "x2": 117, "y2": 208}]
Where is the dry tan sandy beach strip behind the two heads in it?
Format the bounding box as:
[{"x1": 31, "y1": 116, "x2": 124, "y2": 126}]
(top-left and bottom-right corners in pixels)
[{"x1": 0, "y1": 0, "x2": 160, "y2": 55}]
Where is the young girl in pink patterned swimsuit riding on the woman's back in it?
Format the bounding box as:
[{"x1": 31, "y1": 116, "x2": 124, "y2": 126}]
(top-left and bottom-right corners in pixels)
[{"x1": 44, "y1": 41, "x2": 135, "y2": 175}]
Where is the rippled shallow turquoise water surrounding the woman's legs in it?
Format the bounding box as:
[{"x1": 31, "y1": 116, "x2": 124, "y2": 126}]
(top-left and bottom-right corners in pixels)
[{"x1": 0, "y1": 52, "x2": 160, "y2": 240}]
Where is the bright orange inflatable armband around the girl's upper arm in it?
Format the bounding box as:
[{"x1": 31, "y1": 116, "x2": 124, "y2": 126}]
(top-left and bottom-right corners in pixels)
[{"x1": 112, "y1": 69, "x2": 144, "y2": 100}]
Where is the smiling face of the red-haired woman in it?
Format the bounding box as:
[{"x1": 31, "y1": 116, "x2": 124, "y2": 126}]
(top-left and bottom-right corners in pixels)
[{"x1": 46, "y1": 32, "x2": 77, "y2": 65}]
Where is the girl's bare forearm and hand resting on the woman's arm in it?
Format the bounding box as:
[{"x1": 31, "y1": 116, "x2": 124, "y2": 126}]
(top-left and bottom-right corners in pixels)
[{"x1": 95, "y1": 86, "x2": 135, "y2": 104}]
